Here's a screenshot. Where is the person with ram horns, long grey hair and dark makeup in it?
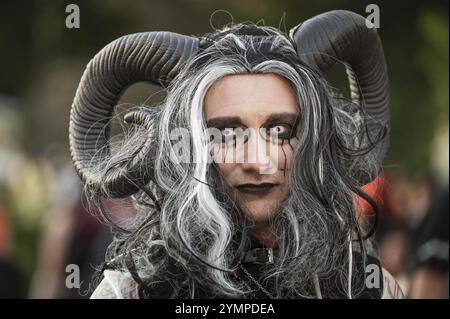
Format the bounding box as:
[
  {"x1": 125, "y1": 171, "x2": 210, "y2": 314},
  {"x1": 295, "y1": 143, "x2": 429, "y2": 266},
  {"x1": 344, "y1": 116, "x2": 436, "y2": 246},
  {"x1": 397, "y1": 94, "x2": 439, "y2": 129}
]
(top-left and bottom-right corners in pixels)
[{"x1": 69, "y1": 10, "x2": 402, "y2": 298}]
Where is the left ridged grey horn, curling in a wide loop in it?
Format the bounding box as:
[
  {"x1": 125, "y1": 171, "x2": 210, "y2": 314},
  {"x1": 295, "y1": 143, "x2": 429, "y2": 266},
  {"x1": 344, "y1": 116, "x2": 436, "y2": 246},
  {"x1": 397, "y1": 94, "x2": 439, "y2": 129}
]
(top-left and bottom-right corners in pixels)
[{"x1": 69, "y1": 32, "x2": 198, "y2": 197}]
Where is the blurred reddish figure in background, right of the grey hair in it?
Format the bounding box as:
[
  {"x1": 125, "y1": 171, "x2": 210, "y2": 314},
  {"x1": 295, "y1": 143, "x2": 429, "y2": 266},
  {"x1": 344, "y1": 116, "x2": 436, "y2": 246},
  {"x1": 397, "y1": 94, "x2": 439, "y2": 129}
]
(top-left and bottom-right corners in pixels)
[{"x1": 374, "y1": 167, "x2": 433, "y2": 293}]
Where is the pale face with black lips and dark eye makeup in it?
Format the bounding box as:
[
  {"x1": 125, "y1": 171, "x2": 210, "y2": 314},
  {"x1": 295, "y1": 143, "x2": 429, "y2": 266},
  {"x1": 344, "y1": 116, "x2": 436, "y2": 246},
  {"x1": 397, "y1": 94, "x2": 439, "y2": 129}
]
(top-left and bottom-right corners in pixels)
[{"x1": 204, "y1": 73, "x2": 299, "y2": 225}]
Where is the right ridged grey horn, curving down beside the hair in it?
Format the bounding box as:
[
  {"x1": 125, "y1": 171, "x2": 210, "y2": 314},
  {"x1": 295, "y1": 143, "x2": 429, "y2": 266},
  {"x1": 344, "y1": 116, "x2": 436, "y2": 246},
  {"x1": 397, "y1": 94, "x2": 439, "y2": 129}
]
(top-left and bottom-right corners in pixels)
[{"x1": 290, "y1": 10, "x2": 389, "y2": 184}]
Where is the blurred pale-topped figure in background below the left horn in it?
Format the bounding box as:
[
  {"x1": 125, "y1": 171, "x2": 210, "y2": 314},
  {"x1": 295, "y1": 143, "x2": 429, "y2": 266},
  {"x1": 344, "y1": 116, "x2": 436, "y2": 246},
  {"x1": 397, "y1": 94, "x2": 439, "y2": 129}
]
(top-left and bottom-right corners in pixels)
[{"x1": 30, "y1": 167, "x2": 112, "y2": 298}]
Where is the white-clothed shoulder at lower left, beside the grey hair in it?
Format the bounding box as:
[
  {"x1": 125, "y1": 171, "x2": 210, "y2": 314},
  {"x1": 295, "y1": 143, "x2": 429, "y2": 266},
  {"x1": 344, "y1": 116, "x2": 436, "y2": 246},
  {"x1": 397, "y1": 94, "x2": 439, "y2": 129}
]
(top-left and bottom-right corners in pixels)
[{"x1": 91, "y1": 270, "x2": 138, "y2": 299}]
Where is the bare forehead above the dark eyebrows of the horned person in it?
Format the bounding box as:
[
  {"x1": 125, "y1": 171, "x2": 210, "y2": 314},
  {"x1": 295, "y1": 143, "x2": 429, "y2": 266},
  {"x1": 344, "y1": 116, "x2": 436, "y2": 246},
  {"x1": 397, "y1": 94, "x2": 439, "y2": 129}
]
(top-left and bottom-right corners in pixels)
[{"x1": 204, "y1": 73, "x2": 298, "y2": 120}]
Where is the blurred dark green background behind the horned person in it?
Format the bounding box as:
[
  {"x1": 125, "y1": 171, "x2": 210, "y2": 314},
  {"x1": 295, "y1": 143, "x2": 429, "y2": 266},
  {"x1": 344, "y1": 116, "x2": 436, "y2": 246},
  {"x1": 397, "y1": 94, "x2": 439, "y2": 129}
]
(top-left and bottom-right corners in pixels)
[{"x1": 0, "y1": 0, "x2": 449, "y2": 298}]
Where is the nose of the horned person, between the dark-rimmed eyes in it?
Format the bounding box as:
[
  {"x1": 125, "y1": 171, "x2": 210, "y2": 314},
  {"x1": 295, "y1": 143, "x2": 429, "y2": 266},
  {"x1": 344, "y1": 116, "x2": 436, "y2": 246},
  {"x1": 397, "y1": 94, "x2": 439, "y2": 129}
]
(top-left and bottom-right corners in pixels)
[{"x1": 236, "y1": 128, "x2": 278, "y2": 174}]
